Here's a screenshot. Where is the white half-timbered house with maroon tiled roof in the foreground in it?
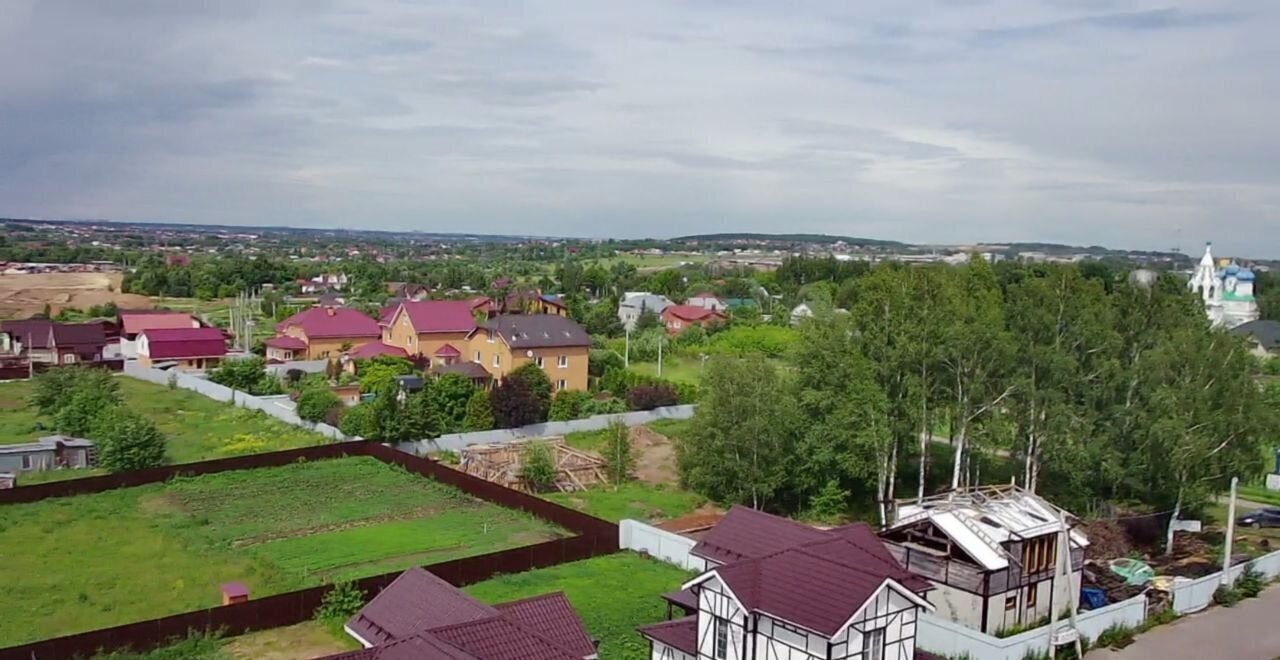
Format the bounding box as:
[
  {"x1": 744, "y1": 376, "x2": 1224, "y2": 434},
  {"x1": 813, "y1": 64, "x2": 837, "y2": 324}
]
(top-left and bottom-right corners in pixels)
[{"x1": 639, "y1": 507, "x2": 932, "y2": 660}]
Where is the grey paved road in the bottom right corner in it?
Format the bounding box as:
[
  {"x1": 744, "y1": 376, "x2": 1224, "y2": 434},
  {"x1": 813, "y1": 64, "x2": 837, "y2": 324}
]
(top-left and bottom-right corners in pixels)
[{"x1": 1085, "y1": 587, "x2": 1280, "y2": 660}]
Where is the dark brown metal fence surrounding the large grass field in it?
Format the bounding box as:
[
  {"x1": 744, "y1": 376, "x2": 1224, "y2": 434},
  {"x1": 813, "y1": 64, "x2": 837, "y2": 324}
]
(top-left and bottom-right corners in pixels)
[{"x1": 0, "y1": 443, "x2": 618, "y2": 660}]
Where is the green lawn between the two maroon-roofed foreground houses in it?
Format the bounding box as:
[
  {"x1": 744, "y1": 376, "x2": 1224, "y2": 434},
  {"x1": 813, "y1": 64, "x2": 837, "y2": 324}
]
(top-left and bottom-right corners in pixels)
[{"x1": 466, "y1": 553, "x2": 692, "y2": 660}]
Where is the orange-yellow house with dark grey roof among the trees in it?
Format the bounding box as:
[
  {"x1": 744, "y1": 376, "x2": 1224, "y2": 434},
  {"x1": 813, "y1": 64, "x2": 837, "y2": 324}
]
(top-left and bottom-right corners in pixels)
[{"x1": 467, "y1": 313, "x2": 591, "y2": 391}]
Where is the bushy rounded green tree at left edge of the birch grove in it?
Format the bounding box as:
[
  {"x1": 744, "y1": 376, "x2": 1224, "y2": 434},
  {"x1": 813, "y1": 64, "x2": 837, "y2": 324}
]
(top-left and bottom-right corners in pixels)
[{"x1": 676, "y1": 357, "x2": 799, "y2": 509}]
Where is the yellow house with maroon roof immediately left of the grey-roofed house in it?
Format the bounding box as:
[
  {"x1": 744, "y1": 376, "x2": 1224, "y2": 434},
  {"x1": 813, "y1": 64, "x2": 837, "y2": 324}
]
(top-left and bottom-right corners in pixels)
[{"x1": 381, "y1": 301, "x2": 476, "y2": 365}]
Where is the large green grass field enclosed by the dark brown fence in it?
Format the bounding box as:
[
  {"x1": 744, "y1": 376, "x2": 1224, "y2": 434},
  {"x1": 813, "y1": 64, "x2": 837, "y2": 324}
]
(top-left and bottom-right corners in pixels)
[{"x1": 0, "y1": 458, "x2": 563, "y2": 647}]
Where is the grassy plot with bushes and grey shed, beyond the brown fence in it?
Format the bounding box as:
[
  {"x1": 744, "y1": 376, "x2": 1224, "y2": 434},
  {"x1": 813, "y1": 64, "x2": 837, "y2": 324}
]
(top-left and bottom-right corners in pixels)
[{"x1": 0, "y1": 376, "x2": 328, "y2": 468}]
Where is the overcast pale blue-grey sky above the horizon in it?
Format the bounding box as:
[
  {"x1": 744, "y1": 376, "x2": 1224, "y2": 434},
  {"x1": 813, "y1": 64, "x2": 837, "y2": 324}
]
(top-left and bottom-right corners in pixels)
[{"x1": 0, "y1": 0, "x2": 1280, "y2": 257}]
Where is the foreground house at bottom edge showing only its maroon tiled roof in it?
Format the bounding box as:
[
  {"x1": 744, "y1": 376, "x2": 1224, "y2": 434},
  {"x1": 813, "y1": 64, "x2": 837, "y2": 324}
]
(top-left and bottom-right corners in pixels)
[{"x1": 324, "y1": 568, "x2": 598, "y2": 660}]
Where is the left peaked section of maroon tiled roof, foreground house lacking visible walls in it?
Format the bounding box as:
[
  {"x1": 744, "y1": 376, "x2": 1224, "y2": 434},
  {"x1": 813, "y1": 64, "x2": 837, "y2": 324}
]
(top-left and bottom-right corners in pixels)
[{"x1": 347, "y1": 568, "x2": 498, "y2": 645}]
